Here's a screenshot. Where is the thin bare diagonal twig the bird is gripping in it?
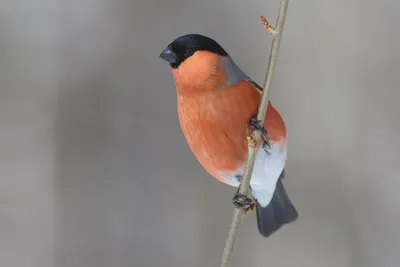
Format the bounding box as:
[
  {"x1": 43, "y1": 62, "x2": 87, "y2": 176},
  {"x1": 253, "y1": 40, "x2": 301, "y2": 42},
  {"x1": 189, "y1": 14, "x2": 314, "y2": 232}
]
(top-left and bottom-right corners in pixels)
[{"x1": 220, "y1": 0, "x2": 289, "y2": 267}]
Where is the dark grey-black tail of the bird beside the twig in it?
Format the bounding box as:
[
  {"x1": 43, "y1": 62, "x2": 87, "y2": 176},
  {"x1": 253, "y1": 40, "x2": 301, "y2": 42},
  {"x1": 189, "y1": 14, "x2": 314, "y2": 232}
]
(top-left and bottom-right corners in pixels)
[{"x1": 256, "y1": 172, "x2": 299, "y2": 240}]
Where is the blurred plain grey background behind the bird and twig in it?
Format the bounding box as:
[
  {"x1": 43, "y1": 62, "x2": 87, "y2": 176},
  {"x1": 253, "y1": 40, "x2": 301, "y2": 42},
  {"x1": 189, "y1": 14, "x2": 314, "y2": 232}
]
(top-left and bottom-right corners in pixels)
[{"x1": 0, "y1": 0, "x2": 400, "y2": 267}]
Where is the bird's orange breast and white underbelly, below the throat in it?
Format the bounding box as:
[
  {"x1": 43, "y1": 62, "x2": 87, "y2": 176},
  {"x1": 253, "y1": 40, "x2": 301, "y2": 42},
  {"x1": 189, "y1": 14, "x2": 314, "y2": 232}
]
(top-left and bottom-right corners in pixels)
[{"x1": 178, "y1": 87, "x2": 286, "y2": 206}]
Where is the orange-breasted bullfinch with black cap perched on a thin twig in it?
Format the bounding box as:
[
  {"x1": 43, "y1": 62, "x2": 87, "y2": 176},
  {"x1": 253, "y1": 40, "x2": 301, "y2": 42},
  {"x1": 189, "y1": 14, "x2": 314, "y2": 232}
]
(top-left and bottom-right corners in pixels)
[{"x1": 159, "y1": 33, "x2": 298, "y2": 237}]
